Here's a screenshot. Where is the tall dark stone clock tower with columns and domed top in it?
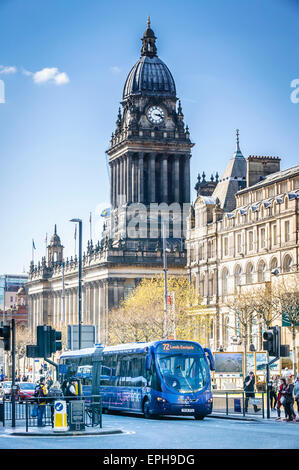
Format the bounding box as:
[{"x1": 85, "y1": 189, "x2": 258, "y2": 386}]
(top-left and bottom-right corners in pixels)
[{"x1": 107, "y1": 20, "x2": 193, "y2": 249}]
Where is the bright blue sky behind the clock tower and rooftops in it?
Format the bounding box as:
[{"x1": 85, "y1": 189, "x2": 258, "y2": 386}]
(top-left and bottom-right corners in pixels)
[{"x1": 0, "y1": 0, "x2": 299, "y2": 273}]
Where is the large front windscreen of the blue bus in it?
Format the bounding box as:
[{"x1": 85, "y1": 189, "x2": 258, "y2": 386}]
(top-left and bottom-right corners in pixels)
[{"x1": 157, "y1": 352, "x2": 209, "y2": 393}]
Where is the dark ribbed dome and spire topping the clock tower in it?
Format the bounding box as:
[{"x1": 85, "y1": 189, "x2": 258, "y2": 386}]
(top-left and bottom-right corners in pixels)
[{"x1": 123, "y1": 19, "x2": 176, "y2": 100}]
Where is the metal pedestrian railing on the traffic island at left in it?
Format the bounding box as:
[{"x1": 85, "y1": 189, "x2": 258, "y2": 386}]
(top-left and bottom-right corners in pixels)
[{"x1": 0, "y1": 395, "x2": 102, "y2": 432}]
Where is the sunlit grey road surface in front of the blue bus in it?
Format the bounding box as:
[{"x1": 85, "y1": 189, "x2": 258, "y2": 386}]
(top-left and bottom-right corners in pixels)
[{"x1": 0, "y1": 413, "x2": 299, "y2": 450}]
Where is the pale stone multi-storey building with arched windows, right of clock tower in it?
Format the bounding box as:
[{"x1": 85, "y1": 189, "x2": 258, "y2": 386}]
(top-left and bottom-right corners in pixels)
[{"x1": 186, "y1": 136, "x2": 299, "y2": 362}]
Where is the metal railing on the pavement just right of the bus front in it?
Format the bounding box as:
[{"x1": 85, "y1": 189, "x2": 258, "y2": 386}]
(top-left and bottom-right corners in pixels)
[{"x1": 213, "y1": 390, "x2": 267, "y2": 418}]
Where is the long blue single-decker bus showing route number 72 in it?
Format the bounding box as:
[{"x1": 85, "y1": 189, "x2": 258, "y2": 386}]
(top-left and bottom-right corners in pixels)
[{"x1": 60, "y1": 340, "x2": 215, "y2": 420}]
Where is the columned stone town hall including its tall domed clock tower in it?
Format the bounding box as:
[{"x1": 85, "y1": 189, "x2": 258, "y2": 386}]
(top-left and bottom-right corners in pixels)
[{"x1": 28, "y1": 21, "x2": 193, "y2": 343}]
